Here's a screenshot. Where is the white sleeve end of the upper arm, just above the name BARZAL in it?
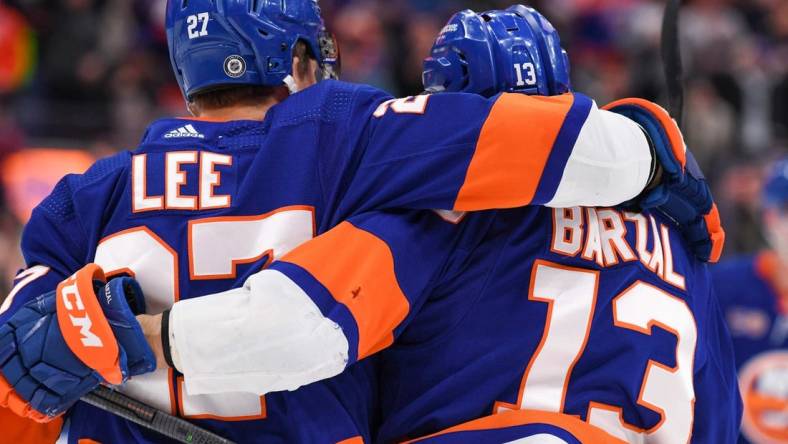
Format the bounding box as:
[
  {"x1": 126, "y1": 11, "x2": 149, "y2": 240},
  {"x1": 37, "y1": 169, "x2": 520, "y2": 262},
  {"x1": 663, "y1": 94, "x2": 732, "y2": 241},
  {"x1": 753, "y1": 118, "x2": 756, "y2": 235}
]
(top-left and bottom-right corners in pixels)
[{"x1": 547, "y1": 105, "x2": 652, "y2": 208}]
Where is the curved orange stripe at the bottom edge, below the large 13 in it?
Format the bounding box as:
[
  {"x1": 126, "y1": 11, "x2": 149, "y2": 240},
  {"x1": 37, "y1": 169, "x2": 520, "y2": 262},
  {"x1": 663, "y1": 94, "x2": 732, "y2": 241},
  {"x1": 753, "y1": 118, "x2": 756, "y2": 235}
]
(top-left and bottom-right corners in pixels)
[{"x1": 408, "y1": 410, "x2": 625, "y2": 444}]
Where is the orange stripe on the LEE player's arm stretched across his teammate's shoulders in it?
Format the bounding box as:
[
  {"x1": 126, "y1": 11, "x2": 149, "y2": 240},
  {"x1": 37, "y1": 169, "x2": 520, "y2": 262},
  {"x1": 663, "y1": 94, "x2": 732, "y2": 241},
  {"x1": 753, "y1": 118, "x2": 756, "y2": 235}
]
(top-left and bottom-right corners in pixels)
[{"x1": 454, "y1": 94, "x2": 574, "y2": 211}]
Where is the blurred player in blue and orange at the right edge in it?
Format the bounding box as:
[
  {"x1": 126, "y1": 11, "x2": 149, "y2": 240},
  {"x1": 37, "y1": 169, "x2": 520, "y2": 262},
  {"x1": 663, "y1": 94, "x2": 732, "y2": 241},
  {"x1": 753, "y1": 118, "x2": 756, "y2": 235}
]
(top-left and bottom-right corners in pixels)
[{"x1": 712, "y1": 159, "x2": 788, "y2": 443}]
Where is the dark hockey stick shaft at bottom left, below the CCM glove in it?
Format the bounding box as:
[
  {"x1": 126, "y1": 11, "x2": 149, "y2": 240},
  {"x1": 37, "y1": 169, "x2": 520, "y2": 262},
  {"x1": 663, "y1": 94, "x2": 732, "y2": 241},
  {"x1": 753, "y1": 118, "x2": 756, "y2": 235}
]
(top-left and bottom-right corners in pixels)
[{"x1": 82, "y1": 385, "x2": 234, "y2": 444}]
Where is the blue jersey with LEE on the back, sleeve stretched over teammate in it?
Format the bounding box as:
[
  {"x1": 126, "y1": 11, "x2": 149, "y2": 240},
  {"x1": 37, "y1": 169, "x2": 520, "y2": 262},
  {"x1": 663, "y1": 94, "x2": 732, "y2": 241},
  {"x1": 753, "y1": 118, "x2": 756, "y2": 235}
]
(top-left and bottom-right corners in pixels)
[{"x1": 0, "y1": 81, "x2": 650, "y2": 443}]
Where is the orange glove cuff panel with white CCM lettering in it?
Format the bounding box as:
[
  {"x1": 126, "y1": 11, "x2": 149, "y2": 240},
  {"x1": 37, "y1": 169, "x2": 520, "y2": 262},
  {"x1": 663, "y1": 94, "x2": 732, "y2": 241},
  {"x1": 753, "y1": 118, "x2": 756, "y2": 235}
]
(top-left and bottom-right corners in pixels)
[{"x1": 57, "y1": 264, "x2": 123, "y2": 384}]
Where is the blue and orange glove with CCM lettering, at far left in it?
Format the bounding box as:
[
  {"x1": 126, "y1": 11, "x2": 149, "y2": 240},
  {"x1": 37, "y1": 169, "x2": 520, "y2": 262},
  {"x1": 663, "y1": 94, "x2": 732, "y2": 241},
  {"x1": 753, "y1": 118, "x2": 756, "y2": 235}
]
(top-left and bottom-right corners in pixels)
[{"x1": 0, "y1": 264, "x2": 156, "y2": 422}]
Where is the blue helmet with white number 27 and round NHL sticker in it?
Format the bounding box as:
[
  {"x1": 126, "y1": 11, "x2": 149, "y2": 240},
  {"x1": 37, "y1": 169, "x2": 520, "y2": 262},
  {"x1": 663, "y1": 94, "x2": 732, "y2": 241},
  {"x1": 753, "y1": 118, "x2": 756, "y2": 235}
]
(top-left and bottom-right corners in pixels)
[{"x1": 166, "y1": 0, "x2": 338, "y2": 101}]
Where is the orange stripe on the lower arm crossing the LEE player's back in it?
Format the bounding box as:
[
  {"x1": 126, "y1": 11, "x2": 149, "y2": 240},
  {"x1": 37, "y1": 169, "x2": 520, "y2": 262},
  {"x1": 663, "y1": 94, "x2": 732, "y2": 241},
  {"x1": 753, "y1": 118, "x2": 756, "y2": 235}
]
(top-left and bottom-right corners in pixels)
[{"x1": 282, "y1": 222, "x2": 410, "y2": 359}]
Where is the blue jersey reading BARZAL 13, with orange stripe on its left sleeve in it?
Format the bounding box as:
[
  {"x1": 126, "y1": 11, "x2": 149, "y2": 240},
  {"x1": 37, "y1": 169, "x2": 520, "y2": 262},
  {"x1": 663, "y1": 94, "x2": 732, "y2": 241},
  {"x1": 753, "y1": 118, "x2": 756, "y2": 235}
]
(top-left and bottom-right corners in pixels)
[{"x1": 271, "y1": 208, "x2": 741, "y2": 443}]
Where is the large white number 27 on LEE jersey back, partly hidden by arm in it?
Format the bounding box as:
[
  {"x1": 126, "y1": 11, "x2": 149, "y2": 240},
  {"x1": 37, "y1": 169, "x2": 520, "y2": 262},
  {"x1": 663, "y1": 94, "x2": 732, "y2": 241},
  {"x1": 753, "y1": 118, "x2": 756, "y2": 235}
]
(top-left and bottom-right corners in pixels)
[{"x1": 94, "y1": 206, "x2": 315, "y2": 421}]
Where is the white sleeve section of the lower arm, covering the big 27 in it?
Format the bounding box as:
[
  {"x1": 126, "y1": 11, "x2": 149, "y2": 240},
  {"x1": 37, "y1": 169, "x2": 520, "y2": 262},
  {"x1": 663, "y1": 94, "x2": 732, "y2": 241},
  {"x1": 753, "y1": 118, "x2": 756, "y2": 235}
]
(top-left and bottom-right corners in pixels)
[{"x1": 170, "y1": 270, "x2": 348, "y2": 395}]
